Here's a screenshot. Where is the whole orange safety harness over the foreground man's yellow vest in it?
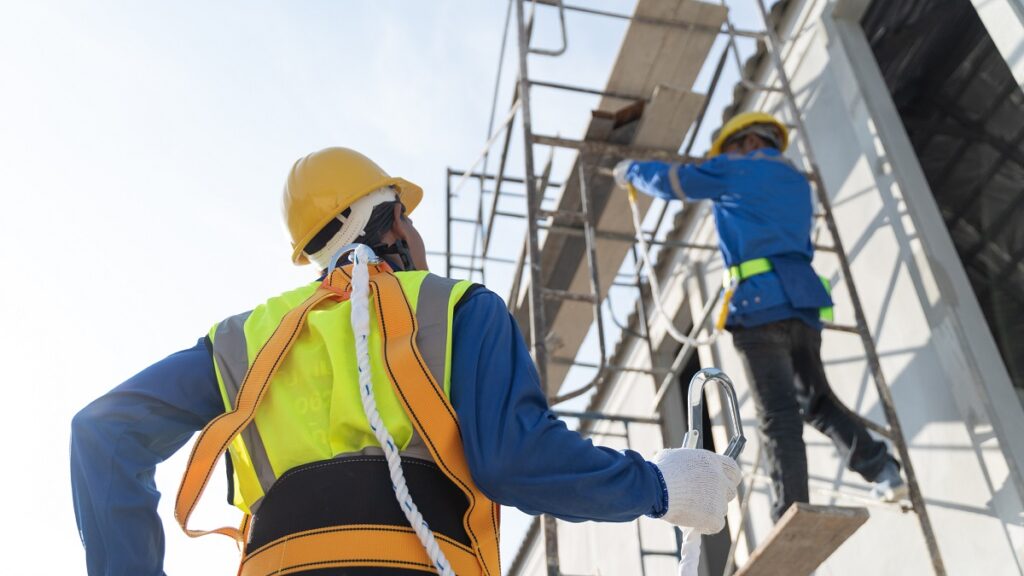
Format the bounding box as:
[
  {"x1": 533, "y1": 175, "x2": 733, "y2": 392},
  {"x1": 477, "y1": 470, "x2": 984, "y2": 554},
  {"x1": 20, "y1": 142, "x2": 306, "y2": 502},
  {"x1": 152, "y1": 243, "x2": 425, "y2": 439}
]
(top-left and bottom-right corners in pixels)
[{"x1": 174, "y1": 262, "x2": 501, "y2": 576}]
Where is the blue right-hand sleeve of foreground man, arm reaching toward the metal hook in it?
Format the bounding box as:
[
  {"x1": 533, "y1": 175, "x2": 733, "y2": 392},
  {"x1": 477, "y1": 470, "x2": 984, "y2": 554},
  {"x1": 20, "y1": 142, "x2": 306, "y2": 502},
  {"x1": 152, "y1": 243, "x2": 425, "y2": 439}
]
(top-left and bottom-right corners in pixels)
[{"x1": 452, "y1": 288, "x2": 667, "y2": 522}]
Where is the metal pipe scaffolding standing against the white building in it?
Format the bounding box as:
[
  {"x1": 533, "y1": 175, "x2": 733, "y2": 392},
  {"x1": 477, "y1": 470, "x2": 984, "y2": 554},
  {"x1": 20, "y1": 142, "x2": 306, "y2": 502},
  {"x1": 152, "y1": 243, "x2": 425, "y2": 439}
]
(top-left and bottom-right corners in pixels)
[{"x1": 444, "y1": 0, "x2": 945, "y2": 576}]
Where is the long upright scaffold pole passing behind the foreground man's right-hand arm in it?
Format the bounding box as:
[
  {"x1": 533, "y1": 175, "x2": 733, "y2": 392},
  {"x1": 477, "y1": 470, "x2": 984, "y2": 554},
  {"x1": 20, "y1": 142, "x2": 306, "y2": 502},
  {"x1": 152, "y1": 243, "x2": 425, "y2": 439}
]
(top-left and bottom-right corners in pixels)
[{"x1": 515, "y1": 0, "x2": 559, "y2": 576}]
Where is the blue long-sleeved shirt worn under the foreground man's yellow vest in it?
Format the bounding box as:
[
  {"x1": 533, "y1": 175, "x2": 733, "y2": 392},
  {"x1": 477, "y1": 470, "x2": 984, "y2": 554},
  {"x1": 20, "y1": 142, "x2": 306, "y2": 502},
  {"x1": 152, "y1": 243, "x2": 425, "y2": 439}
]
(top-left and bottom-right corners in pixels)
[{"x1": 71, "y1": 287, "x2": 668, "y2": 576}]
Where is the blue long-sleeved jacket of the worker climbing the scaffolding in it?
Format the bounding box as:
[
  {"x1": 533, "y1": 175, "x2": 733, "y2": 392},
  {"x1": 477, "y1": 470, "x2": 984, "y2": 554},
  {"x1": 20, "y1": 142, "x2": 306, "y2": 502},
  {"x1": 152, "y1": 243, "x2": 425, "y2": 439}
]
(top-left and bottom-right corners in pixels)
[{"x1": 627, "y1": 148, "x2": 831, "y2": 328}]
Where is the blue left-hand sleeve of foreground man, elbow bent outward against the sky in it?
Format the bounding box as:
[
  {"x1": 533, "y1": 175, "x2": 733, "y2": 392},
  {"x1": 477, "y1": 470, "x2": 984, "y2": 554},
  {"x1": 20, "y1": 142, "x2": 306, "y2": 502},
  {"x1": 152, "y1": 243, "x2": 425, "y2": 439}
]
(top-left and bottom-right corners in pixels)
[{"x1": 71, "y1": 338, "x2": 224, "y2": 576}]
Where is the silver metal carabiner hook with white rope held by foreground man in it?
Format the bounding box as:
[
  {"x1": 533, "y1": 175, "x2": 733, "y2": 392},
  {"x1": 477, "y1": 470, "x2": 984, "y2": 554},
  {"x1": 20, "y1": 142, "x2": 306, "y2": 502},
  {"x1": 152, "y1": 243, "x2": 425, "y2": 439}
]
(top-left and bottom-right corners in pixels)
[{"x1": 679, "y1": 368, "x2": 746, "y2": 576}]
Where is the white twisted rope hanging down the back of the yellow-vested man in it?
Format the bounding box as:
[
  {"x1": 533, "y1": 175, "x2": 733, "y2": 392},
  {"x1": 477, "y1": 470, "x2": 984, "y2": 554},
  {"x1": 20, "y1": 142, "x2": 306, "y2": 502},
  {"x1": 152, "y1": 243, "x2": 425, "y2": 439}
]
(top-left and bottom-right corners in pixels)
[{"x1": 351, "y1": 244, "x2": 455, "y2": 576}]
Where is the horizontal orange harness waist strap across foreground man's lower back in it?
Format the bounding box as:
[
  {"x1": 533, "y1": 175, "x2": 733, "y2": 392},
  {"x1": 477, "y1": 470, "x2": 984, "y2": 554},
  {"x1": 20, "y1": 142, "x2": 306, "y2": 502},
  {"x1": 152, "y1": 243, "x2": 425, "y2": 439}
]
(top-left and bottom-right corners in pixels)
[{"x1": 239, "y1": 525, "x2": 479, "y2": 576}]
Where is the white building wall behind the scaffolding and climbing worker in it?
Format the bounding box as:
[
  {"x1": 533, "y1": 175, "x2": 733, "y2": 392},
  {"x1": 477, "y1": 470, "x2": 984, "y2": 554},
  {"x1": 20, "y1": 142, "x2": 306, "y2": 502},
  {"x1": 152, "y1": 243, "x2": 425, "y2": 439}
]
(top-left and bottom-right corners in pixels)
[{"x1": 512, "y1": 0, "x2": 1024, "y2": 575}]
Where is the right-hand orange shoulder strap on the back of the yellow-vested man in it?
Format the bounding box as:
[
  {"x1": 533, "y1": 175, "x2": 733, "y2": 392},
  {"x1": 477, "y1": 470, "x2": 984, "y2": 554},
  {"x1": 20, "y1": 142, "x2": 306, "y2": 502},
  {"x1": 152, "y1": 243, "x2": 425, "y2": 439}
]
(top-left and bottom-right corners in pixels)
[{"x1": 356, "y1": 270, "x2": 501, "y2": 576}]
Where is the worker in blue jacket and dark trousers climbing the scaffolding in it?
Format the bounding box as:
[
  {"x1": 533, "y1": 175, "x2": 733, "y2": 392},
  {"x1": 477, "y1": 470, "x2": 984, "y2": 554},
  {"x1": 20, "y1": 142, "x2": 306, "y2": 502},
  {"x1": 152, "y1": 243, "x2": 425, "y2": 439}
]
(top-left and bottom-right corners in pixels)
[{"x1": 614, "y1": 112, "x2": 905, "y2": 521}]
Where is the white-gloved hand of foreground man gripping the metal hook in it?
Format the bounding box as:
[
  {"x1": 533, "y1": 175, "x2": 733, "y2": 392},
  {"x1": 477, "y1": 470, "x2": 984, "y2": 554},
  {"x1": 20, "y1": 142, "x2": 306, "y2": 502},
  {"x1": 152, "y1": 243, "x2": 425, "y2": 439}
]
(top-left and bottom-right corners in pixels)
[{"x1": 651, "y1": 448, "x2": 742, "y2": 534}]
